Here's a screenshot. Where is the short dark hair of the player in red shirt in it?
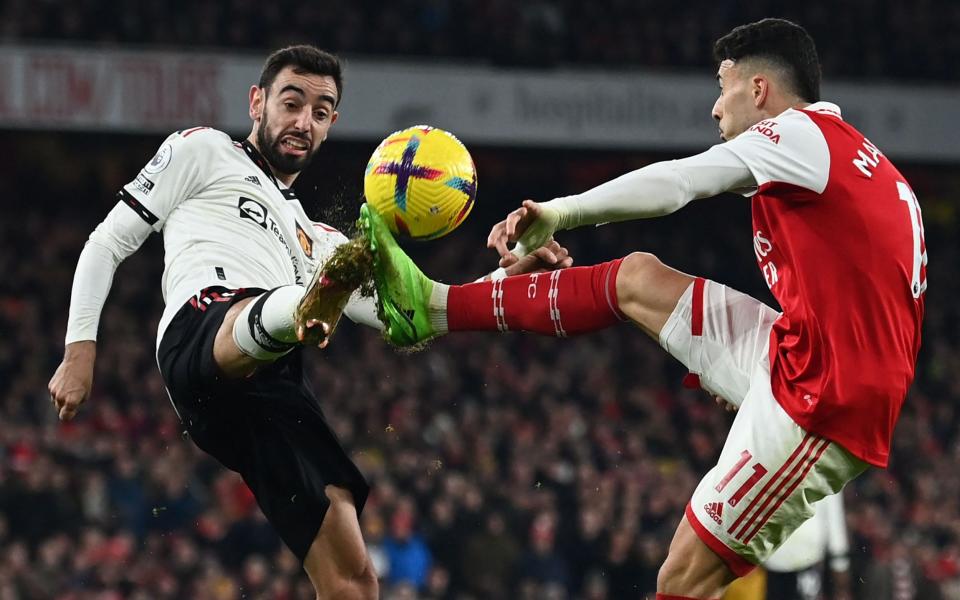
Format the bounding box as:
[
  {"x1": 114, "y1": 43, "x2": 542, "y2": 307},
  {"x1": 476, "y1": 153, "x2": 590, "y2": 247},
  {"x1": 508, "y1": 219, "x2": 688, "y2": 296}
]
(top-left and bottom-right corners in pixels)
[{"x1": 713, "y1": 19, "x2": 820, "y2": 102}]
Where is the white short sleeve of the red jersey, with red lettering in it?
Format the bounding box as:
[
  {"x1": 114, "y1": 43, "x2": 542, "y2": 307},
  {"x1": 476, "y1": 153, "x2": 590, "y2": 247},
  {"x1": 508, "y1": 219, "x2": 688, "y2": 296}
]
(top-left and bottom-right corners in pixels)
[{"x1": 715, "y1": 109, "x2": 830, "y2": 196}]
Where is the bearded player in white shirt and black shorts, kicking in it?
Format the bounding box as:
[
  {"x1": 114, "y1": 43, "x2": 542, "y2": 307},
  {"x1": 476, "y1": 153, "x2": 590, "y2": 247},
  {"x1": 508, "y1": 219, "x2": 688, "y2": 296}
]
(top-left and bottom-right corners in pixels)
[{"x1": 49, "y1": 46, "x2": 570, "y2": 599}]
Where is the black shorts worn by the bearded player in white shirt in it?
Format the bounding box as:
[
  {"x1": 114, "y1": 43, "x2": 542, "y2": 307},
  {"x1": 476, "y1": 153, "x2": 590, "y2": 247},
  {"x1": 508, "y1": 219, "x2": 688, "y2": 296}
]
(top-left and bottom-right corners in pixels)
[{"x1": 157, "y1": 287, "x2": 370, "y2": 561}]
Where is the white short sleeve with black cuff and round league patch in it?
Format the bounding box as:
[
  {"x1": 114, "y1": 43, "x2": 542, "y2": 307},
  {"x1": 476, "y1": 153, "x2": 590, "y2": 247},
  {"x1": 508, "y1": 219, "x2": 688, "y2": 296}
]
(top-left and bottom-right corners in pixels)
[{"x1": 118, "y1": 128, "x2": 214, "y2": 231}]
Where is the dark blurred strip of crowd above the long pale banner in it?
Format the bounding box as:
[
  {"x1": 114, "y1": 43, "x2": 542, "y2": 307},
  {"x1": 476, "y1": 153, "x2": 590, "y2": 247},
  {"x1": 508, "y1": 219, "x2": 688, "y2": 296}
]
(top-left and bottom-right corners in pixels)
[{"x1": 0, "y1": 0, "x2": 960, "y2": 81}]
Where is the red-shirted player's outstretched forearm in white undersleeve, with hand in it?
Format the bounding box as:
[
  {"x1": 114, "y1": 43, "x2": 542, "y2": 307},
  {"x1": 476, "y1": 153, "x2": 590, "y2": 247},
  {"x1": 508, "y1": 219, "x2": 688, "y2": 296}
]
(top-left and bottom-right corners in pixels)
[{"x1": 487, "y1": 145, "x2": 756, "y2": 266}]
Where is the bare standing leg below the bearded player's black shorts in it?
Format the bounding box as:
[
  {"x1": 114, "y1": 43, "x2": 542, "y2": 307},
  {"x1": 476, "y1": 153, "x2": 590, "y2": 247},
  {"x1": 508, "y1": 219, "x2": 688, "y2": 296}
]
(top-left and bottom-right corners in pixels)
[{"x1": 303, "y1": 485, "x2": 379, "y2": 600}]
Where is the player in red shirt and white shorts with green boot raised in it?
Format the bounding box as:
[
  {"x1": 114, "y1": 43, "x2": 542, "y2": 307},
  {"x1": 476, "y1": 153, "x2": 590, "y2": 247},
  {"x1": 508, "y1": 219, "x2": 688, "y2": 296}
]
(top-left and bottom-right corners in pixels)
[{"x1": 362, "y1": 19, "x2": 927, "y2": 600}]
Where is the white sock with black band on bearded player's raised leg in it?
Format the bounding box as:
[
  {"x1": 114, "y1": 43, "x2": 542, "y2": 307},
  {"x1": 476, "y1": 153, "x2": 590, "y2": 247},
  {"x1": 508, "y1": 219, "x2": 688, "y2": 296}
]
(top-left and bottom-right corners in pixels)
[{"x1": 233, "y1": 285, "x2": 306, "y2": 360}]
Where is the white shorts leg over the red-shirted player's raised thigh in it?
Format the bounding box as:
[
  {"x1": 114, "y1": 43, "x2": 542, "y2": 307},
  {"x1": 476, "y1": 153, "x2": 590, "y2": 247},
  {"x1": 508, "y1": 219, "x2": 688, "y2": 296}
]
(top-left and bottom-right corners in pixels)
[{"x1": 660, "y1": 278, "x2": 779, "y2": 406}]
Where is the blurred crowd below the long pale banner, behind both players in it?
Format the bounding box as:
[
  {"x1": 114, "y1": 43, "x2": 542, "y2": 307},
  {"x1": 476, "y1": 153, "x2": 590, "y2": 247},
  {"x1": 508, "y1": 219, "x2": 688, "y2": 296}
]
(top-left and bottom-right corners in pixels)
[{"x1": 0, "y1": 132, "x2": 960, "y2": 600}]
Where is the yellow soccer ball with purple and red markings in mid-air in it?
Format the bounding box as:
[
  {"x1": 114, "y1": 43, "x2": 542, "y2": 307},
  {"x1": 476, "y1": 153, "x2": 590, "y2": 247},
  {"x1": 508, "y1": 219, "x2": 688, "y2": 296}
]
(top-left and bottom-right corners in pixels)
[{"x1": 363, "y1": 125, "x2": 477, "y2": 240}]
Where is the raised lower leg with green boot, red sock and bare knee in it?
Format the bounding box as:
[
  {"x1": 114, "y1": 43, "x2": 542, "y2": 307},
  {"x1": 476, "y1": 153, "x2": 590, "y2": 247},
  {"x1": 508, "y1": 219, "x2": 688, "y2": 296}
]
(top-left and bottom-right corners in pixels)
[{"x1": 361, "y1": 207, "x2": 693, "y2": 345}]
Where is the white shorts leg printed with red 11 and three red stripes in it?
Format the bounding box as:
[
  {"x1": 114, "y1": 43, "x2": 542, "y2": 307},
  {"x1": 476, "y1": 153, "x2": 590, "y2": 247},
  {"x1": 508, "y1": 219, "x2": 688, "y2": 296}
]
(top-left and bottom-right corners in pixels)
[{"x1": 686, "y1": 361, "x2": 868, "y2": 575}]
